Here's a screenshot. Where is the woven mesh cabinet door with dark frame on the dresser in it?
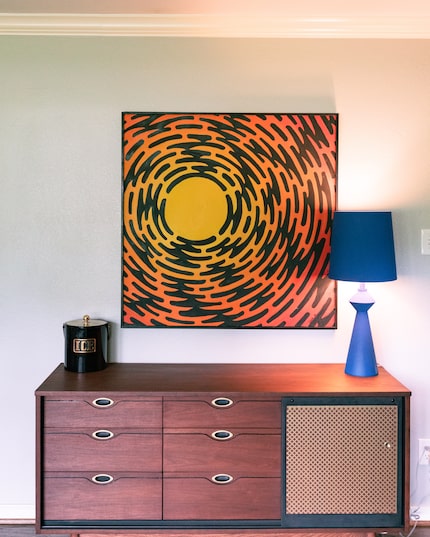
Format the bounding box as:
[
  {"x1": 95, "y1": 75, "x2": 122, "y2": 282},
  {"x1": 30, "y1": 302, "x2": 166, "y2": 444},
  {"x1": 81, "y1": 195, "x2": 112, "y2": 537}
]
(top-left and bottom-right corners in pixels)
[{"x1": 283, "y1": 397, "x2": 405, "y2": 528}]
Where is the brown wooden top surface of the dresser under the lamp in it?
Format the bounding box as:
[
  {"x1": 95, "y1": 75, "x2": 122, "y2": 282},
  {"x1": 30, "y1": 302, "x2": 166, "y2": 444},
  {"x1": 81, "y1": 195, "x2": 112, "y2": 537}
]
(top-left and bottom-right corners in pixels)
[{"x1": 36, "y1": 363, "x2": 410, "y2": 396}]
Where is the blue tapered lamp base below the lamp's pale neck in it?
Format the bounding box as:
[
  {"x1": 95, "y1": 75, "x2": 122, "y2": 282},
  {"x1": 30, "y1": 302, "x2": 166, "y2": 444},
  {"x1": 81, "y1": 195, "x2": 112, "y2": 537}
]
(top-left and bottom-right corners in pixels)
[{"x1": 345, "y1": 301, "x2": 378, "y2": 377}]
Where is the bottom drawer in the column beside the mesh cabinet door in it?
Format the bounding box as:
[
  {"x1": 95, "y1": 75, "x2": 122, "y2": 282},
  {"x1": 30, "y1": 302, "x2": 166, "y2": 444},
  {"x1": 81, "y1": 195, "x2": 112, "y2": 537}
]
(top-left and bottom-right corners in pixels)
[{"x1": 163, "y1": 477, "x2": 281, "y2": 520}]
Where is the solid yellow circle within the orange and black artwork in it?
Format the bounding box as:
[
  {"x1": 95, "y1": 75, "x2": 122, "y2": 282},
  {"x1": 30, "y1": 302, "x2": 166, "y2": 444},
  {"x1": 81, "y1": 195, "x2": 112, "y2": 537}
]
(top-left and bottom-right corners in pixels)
[{"x1": 165, "y1": 177, "x2": 227, "y2": 240}]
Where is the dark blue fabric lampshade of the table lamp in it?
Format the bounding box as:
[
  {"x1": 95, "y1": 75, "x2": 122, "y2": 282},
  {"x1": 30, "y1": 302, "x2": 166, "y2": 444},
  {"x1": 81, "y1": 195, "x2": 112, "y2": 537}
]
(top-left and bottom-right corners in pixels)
[{"x1": 328, "y1": 211, "x2": 397, "y2": 282}]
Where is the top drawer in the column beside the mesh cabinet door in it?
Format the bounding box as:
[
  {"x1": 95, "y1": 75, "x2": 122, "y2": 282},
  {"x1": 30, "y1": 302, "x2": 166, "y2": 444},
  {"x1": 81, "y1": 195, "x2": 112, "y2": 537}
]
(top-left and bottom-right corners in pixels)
[{"x1": 163, "y1": 396, "x2": 281, "y2": 429}]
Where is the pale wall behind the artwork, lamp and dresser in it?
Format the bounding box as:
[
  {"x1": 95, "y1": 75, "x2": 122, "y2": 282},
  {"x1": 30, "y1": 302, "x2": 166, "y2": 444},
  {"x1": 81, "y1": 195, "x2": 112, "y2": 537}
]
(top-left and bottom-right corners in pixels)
[{"x1": 0, "y1": 37, "x2": 430, "y2": 519}]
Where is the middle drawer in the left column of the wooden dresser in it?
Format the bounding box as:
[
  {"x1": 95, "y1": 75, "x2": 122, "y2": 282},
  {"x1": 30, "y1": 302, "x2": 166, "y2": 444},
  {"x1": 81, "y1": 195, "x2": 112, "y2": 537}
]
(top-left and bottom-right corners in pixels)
[{"x1": 44, "y1": 429, "x2": 162, "y2": 472}]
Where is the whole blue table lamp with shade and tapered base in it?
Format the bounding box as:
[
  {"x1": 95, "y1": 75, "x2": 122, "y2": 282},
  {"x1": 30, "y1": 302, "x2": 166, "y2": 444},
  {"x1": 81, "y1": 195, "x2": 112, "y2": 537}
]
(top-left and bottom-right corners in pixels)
[{"x1": 328, "y1": 211, "x2": 397, "y2": 377}]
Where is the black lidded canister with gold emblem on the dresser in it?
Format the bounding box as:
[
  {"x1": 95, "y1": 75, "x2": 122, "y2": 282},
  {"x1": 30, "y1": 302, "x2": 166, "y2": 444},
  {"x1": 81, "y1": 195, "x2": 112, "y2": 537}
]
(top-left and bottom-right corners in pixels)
[{"x1": 63, "y1": 315, "x2": 109, "y2": 373}]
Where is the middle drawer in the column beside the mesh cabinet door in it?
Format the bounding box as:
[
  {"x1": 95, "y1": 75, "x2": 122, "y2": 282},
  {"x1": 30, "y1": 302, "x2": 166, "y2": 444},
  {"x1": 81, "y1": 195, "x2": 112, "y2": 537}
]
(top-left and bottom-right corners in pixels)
[{"x1": 163, "y1": 429, "x2": 281, "y2": 477}]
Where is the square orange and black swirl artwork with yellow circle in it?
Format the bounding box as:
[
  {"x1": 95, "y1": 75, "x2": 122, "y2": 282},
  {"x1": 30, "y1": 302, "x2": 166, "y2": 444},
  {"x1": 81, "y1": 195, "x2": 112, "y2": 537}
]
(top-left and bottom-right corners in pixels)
[{"x1": 122, "y1": 112, "x2": 338, "y2": 328}]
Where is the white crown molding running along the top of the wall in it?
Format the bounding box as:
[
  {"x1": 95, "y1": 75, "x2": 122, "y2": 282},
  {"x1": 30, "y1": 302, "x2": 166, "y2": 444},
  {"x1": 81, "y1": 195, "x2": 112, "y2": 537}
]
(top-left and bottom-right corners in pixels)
[{"x1": 0, "y1": 13, "x2": 430, "y2": 39}]
